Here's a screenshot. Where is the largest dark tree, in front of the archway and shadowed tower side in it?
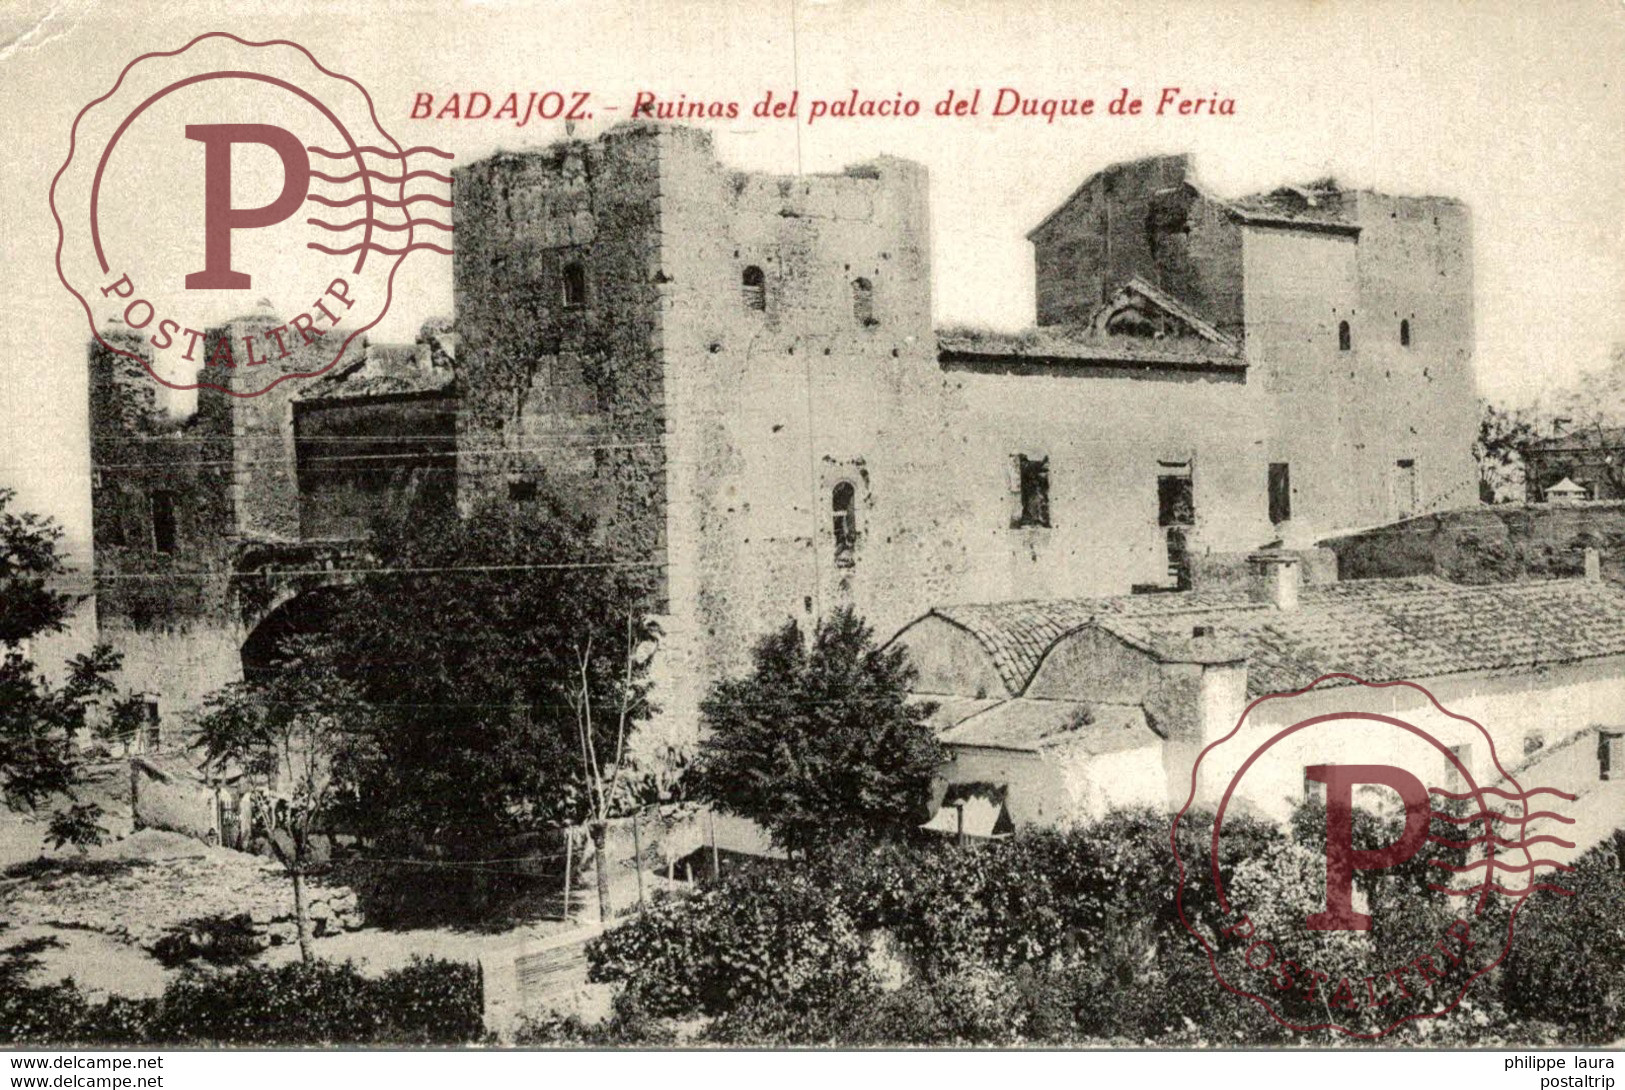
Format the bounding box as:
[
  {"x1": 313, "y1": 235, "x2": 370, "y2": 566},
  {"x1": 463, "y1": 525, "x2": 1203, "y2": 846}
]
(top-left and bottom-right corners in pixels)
[{"x1": 318, "y1": 495, "x2": 658, "y2": 883}]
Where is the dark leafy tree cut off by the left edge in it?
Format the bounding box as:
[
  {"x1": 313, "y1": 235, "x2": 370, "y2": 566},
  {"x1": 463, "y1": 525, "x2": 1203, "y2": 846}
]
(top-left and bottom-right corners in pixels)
[{"x1": 0, "y1": 489, "x2": 133, "y2": 845}]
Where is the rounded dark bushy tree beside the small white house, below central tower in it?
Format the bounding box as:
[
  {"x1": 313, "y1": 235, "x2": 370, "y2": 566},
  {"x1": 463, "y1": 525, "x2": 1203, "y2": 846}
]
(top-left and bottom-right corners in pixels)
[{"x1": 696, "y1": 608, "x2": 947, "y2": 851}]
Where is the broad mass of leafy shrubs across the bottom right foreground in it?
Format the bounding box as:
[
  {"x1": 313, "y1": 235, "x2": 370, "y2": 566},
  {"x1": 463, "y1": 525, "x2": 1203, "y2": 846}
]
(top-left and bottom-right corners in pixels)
[{"x1": 568, "y1": 811, "x2": 1625, "y2": 1046}]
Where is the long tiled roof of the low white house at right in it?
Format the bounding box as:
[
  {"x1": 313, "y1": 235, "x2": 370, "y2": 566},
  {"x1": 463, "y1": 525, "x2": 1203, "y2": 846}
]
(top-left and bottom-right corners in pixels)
[{"x1": 933, "y1": 577, "x2": 1625, "y2": 695}]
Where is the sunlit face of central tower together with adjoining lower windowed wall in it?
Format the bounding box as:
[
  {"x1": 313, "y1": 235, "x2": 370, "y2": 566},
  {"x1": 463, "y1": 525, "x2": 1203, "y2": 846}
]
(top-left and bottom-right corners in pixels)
[{"x1": 658, "y1": 130, "x2": 1269, "y2": 724}]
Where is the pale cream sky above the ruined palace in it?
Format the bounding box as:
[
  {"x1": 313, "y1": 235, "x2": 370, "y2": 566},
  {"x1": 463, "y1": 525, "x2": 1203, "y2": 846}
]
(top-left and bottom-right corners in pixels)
[{"x1": 0, "y1": 0, "x2": 1625, "y2": 539}]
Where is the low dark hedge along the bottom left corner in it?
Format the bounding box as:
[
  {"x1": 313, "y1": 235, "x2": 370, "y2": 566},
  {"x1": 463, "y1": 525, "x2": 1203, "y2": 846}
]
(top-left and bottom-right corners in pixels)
[{"x1": 0, "y1": 944, "x2": 484, "y2": 1046}]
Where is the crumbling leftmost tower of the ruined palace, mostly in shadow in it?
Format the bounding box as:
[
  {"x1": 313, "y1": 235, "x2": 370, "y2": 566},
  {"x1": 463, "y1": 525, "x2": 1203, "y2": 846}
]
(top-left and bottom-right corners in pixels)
[{"x1": 89, "y1": 310, "x2": 362, "y2": 724}]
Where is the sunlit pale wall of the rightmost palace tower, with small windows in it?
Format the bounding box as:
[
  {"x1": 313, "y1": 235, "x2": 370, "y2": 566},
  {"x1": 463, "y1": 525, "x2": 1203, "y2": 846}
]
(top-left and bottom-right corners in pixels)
[{"x1": 1246, "y1": 192, "x2": 1477, "y2": 533}]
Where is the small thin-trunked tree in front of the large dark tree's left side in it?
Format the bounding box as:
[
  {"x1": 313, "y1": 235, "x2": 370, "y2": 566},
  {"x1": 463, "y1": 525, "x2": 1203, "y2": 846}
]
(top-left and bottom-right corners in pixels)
[{"x1": 192, "y1": 637, "x2": 369, "y2": 962}]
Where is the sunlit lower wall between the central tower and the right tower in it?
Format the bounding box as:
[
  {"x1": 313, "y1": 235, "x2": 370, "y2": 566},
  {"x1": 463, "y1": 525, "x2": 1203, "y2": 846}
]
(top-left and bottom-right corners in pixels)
[{"x1": 930, "y1": 365, "x2": 1271, "y2": 604}]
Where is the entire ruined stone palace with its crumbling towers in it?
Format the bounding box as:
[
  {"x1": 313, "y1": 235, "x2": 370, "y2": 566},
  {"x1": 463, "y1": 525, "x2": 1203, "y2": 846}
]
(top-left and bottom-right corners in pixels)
[{"x1": 91, "y1": 116, "x2": 1476, "y2": 750}]
